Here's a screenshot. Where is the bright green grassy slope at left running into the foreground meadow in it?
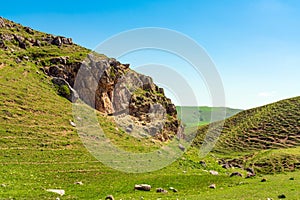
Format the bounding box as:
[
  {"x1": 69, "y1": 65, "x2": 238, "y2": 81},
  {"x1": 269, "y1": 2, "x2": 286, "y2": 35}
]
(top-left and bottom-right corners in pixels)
[{"x1": 0, "y1": 18, "x2": 300, "y2": 199}]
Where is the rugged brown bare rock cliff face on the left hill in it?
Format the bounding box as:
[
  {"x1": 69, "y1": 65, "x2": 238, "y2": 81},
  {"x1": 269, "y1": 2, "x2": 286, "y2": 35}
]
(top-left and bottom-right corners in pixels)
[{"x1": 45, "y1": 54, "x2": 180, "y2": 141}]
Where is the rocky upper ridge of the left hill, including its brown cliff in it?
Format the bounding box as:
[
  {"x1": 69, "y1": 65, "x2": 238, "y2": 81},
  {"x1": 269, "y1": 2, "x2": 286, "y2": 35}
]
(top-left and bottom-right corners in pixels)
[{"x1": 0, "y1": 18, "x2": 181, "y2": 141}]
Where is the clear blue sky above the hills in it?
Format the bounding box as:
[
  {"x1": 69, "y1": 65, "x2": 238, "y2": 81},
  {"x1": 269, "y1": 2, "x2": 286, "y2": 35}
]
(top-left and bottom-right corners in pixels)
[{"x1": 0, "y1": 0, "x2": 300, "y2": 109}]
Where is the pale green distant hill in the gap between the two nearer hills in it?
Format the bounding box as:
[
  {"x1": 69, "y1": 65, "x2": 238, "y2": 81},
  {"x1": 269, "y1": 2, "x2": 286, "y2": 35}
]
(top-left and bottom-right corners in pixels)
[{"x1": 176, "y1": 106, "x2": 242, "y2": 126}]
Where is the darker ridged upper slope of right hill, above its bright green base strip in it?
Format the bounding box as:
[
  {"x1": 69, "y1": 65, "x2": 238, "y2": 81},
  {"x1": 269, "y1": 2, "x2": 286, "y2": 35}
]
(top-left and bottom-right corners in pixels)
[{"x1": 197, "y1": 97, "x2": 300, "y2": 152}]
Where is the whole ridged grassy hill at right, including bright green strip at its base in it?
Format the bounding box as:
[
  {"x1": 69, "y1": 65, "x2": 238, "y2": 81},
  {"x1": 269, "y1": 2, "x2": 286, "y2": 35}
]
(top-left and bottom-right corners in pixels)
[{"x1": 194, "y1": 97, "x2": 300, "y2": 173}]
